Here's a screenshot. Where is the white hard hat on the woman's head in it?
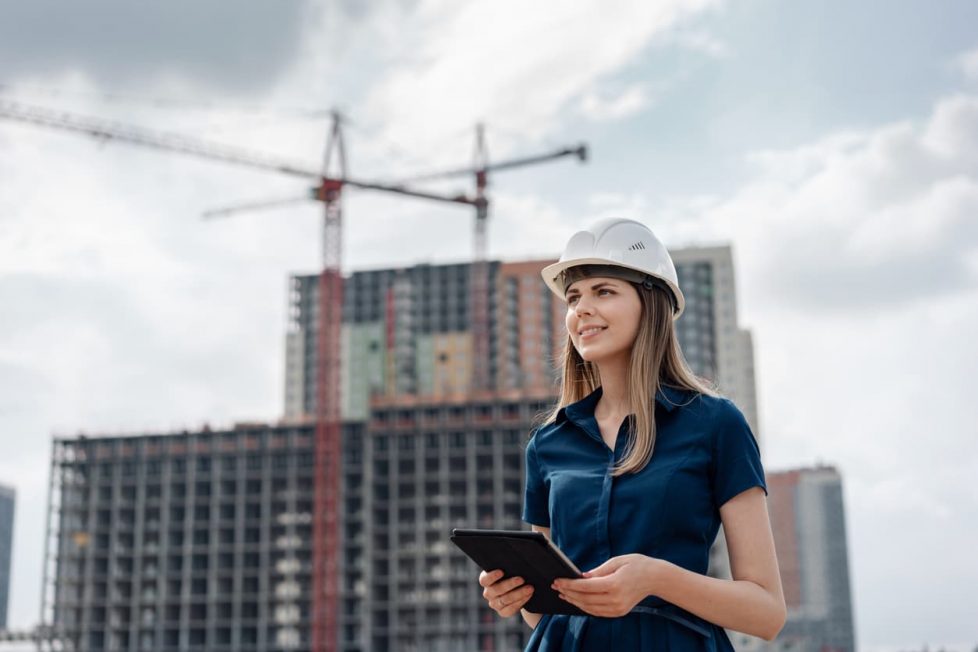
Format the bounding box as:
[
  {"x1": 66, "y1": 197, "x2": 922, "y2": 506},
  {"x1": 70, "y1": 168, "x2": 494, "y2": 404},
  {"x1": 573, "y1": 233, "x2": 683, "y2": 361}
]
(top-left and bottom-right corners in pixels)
[{"x1": 541, "y1": 217, "x2": 686, "y2": 319}]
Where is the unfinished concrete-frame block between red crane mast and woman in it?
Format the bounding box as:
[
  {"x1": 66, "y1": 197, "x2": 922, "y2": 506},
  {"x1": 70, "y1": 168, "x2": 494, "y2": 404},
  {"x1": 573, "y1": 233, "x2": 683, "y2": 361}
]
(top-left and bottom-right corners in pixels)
[{"x1": 345, "y1": 391, "x2": 551, "y2": 652}]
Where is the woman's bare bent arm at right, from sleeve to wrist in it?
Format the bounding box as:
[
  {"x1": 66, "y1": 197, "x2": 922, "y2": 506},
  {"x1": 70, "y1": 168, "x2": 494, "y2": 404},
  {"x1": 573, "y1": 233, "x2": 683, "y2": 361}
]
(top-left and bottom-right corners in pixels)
[{"x1": 649, "y1": 487, "x2": 786, "y2": 641}]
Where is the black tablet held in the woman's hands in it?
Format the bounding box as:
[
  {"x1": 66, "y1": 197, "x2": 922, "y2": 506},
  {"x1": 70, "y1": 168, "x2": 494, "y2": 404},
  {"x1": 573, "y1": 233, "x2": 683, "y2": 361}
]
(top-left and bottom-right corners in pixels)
[{"x1": 452, "y1": 528, "x2": 584, "y2": 615}]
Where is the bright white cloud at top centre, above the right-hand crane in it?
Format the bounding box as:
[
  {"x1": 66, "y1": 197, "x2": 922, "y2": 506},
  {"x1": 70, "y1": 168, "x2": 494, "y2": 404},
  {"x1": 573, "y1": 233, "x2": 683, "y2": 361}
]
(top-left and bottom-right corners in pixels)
[{"x1": 365, "y1": 0, "x2": 717, "y2": 160}]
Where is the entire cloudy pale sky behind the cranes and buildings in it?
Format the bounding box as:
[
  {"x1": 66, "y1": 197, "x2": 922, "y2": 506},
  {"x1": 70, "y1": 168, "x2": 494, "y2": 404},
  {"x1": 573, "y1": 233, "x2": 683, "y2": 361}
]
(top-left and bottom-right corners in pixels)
[{"x1": 0, "y1": 0, "x2": 978, "y2": 651}]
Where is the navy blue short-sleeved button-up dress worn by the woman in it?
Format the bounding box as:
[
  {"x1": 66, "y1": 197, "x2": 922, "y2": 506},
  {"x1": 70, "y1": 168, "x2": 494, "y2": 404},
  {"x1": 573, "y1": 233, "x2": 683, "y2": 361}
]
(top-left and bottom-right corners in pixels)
[{"x1": 523, "y1": 387, "x2": 767, "y2": 652}]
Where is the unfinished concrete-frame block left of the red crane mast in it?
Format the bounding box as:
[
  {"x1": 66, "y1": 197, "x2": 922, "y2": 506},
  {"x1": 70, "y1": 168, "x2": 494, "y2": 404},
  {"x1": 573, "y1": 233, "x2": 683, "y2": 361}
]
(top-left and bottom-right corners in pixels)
[{"x1": 43, "y1": 425, "x2": 324, "y2": 652}]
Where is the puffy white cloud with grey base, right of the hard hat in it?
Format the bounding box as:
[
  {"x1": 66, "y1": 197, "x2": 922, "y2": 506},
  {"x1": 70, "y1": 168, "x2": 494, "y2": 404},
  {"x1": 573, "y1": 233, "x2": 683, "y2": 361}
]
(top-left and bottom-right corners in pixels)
[{"x1": 656, "y1": 95, "x2": 978, "y2": 313}]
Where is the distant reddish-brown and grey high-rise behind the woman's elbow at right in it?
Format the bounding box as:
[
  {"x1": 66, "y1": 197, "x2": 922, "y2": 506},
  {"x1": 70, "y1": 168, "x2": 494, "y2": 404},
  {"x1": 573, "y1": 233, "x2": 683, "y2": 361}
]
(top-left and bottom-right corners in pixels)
[{"x1": 767, "y1": 466, "x2": 855, "y2": 652}]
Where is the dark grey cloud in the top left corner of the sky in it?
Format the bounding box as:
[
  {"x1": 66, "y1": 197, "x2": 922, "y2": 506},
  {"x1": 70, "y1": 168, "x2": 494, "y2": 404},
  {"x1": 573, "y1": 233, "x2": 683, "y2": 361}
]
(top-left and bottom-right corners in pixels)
[{"x1": 0, "y1": 0, "x2": 316, "y2": 93}]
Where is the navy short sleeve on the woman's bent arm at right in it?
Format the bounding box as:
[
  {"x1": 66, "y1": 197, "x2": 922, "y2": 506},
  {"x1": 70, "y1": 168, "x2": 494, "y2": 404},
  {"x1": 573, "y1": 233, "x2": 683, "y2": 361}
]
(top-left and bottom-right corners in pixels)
[{"x1": 712, "y1": 399, "x2": 767, "y2": 509}]
